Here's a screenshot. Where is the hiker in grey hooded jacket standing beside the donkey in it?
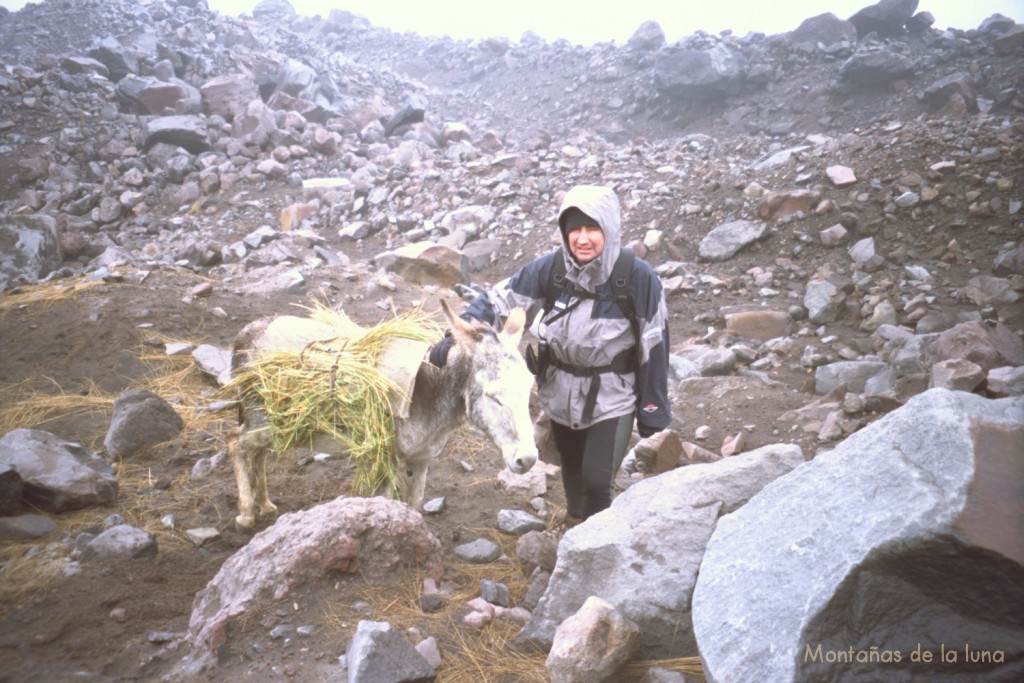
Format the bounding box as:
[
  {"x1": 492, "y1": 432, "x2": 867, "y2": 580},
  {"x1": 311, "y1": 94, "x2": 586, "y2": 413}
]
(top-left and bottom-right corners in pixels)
[{"x1": 429, "y1": 185, "x2": 672, "y2": 519}]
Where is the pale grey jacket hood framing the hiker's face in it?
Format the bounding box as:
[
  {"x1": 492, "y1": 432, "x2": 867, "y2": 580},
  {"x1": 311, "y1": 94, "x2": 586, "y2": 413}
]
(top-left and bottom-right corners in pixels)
[{"x1": 558, "y1": 185, "x2": 623, "y2": 292}]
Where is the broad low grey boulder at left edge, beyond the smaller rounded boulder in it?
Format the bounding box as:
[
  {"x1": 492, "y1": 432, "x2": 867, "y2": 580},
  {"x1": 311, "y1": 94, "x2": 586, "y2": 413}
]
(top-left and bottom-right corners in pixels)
[{"x1": 0, "y1": 429, "x2": 118, "y2": 513}]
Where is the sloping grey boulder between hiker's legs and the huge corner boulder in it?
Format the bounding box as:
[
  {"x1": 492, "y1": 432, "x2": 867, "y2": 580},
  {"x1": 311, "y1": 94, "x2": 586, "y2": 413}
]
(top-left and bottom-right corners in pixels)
[{"x1": 517, "y1": 444, "x2": 804, "y2": 657}]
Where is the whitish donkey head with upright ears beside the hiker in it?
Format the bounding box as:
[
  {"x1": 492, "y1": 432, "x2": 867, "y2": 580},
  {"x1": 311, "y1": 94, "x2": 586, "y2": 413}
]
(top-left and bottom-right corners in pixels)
[{"x1": 441, "y1": 300, "x2": 537, "y2": 474}]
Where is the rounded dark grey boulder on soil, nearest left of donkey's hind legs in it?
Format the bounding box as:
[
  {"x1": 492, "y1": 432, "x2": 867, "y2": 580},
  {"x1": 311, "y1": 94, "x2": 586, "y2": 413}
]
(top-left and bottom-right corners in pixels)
[{"x1": 103, "y1": 389, "x2": 185, "y2": 458}]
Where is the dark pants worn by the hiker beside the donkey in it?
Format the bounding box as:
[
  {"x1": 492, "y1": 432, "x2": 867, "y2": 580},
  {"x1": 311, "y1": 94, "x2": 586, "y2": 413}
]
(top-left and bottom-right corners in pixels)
[{"x1": 551, "y1": 413, "x2": 633, "y2": 519}]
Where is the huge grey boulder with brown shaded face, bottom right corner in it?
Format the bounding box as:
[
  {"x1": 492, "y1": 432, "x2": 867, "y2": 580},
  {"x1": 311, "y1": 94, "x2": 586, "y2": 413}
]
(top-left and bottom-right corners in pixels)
[{"x1": 693, "y1": 389, "x2": 1024, "y2": 683}]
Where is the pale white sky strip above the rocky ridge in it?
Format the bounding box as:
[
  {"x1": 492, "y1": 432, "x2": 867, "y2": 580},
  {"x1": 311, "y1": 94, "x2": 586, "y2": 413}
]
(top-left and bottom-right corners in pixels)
[{"x1": 0, "y1": 0, "x2": 1024, "y2": 45}]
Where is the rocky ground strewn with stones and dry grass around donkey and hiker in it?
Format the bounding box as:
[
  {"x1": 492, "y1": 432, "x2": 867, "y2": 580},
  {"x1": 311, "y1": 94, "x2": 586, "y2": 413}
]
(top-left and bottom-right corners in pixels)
[{"x1": 0, "y1": 0, "x2": 1024, "y2": 681}]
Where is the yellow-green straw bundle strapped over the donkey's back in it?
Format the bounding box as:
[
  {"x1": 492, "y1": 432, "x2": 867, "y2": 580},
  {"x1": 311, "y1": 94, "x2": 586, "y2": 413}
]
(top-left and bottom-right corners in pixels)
[{"x1": 227, "y1": 306, "x2": 440, "y2": 496}]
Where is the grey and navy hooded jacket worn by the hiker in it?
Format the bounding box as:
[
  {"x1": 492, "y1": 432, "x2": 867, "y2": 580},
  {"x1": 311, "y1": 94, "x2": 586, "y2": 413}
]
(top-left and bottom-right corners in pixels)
[{"x1": 464, "y1": 185, "x2": 672, "y2": 430}]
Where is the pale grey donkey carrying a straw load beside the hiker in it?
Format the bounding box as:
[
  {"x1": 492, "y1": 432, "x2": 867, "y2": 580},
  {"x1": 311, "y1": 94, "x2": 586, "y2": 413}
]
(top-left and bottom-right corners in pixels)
[{"x1": 228, "y1": 300, "x2": 538, "y2": 531}]
